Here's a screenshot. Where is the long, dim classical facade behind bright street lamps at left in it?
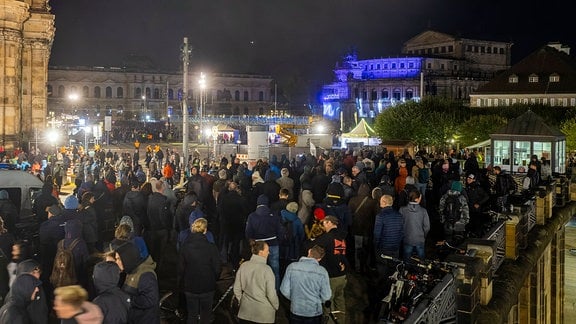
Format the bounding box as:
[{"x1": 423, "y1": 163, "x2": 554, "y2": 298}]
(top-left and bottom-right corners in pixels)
[{"x1": 47, "y1": 67, "x2": 273, "y2": 123}]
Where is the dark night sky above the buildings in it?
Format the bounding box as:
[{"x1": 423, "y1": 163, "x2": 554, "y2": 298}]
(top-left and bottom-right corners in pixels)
[{"x1": 50, "y1": 0, "x2": 576, "y2": 95}]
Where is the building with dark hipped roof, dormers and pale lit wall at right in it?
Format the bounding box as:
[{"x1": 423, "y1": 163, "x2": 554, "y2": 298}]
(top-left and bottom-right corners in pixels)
[{"x1": 470, "y1": 43, "x2": 576, "y2": 107}]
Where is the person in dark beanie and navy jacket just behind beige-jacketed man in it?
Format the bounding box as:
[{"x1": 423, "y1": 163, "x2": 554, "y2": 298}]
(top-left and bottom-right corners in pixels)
[{"x1": 245, "y1": 195, "x2": 282, "y2": 288}]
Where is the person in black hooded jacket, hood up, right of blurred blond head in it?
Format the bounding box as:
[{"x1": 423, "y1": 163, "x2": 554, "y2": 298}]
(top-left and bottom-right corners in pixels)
[{"x1": 92, "y1": 261, "x2": 130, "y2": 324}]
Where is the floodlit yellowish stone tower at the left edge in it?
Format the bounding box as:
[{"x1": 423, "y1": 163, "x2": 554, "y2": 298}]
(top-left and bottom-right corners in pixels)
[{"x1": 0, "y1": 0, "x2": 55, "y2": 150}]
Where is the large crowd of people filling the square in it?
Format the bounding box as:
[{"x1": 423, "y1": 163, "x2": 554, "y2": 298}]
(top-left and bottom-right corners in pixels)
[{"x1": 0, "y1": 145, "x2": 546, "y2": 323}]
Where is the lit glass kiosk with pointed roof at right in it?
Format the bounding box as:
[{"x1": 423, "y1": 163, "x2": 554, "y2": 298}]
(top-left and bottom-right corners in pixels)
[{"x1": 490, "y1": 110, "x2": 566, "y2": 174}]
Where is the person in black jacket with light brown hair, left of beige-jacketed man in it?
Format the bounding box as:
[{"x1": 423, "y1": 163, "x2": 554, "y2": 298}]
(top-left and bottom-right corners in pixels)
[{"x1": 178, "y1": 218, "x2": 222, "y2": 323}]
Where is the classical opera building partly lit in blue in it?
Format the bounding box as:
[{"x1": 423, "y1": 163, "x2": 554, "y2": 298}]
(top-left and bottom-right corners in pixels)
[{"x1": 322, "y1": 31, "x2": 512, "y2": 131}]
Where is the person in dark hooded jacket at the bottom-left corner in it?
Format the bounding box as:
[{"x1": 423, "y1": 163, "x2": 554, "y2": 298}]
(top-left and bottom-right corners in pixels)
[{"x1": 0, "y1": 274, "x2": 42, "y2": 324}]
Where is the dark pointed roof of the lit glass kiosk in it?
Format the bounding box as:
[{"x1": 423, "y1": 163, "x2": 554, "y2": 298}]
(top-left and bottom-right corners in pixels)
[{"x1": 490, "y1": 110, "x2": 565, "y2": 137}]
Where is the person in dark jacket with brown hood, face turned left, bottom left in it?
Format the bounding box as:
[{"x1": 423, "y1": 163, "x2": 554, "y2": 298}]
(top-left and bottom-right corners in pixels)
[{"x1": 116, "y1": 242, "x2": 160, "y2": 324}]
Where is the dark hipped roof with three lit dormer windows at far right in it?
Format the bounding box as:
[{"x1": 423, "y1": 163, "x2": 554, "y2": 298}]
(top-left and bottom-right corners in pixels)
[{"x1": 474, "y1": 45, "x2": 576, "y2": 95}]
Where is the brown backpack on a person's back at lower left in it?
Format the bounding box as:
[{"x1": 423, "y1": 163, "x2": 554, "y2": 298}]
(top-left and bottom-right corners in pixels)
[{"x1": 50, "y1": 239, "x2": 80, "y2": 288}]
